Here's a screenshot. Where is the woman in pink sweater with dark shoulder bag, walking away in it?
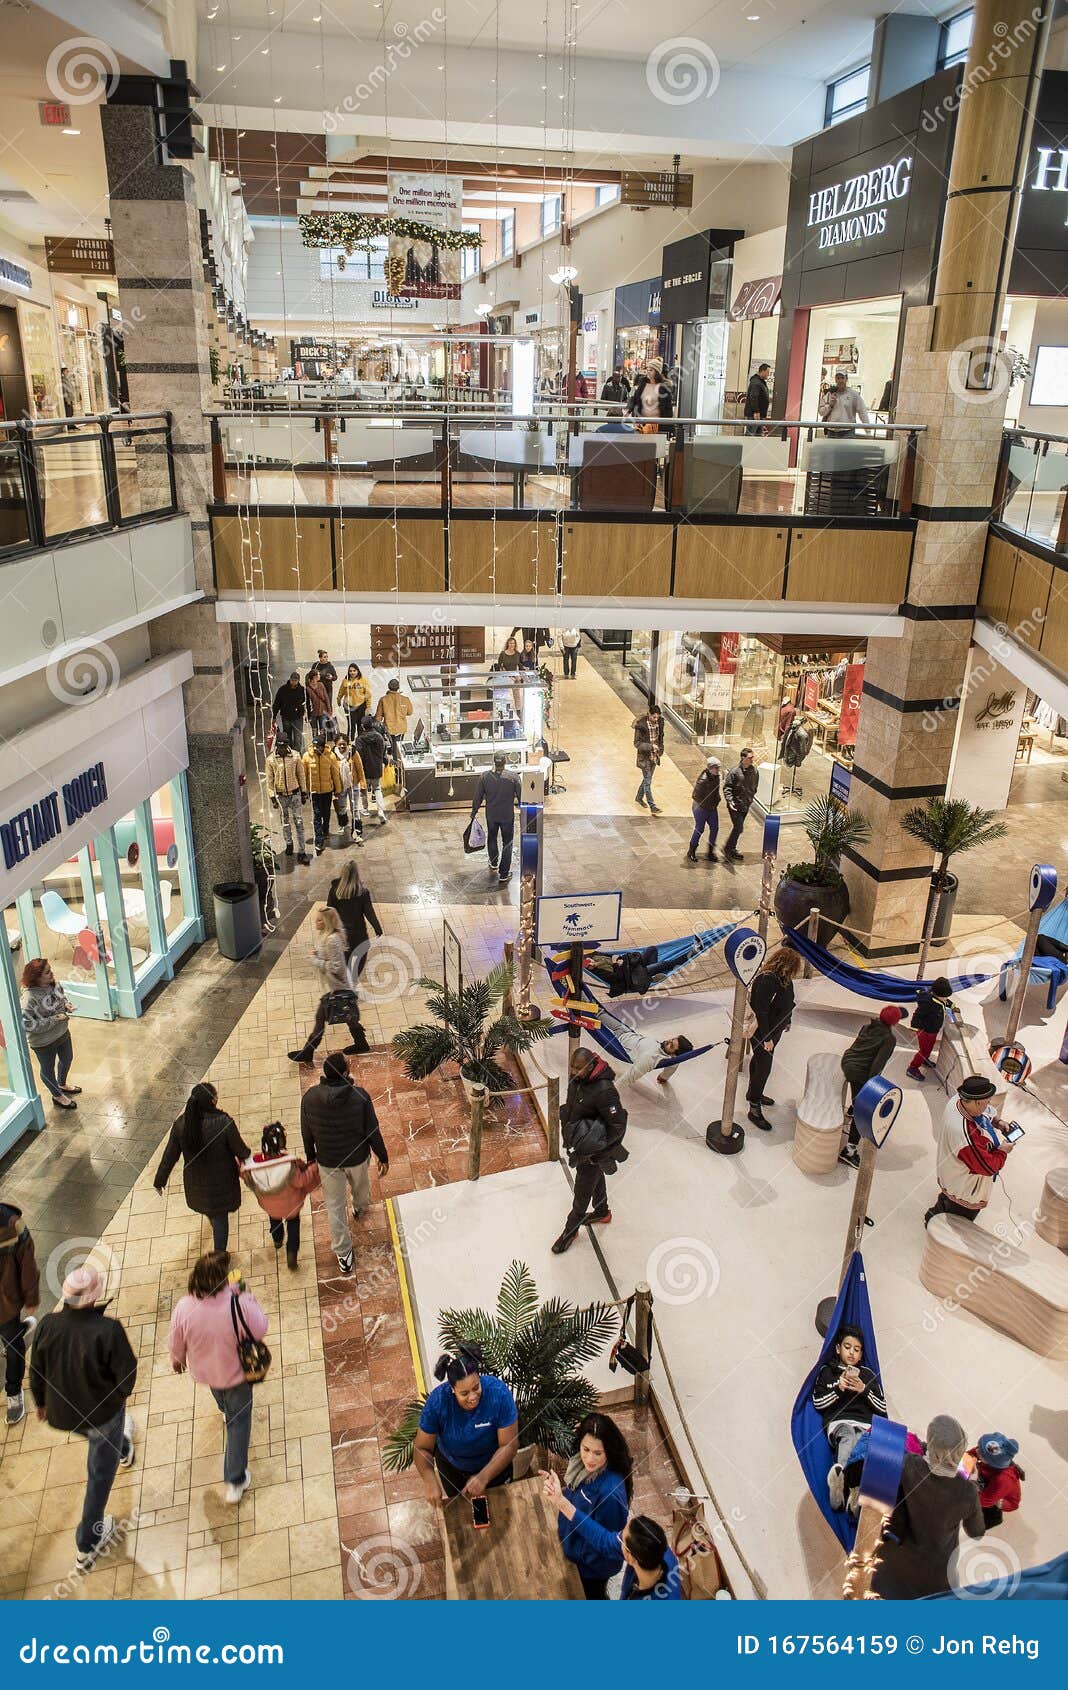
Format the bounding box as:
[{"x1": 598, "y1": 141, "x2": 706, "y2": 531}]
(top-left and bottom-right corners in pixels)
[{"x1": 167, "y1": 1251, "x2": 270, "y2": 1502}]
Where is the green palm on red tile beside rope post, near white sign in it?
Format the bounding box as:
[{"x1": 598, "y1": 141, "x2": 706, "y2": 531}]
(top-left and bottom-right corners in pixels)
[{"x1": 394, "y1": 963, "x2": 553, "y2": 1092}]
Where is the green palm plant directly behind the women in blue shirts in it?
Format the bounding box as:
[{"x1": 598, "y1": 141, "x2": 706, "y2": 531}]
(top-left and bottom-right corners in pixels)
[{"x1": 382, "y1": 1261, "x2": 618, "y2": 1474}]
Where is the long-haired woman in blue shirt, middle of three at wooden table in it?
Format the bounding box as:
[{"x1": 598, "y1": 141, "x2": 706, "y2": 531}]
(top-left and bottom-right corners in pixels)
[{"x1": 556, "y1": 1415, "x2": 634, "y2": 1602}]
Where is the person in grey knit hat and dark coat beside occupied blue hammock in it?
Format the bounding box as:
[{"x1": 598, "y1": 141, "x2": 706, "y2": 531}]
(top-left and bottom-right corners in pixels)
[{"x1": 872, "y1": 1415, "x2": 987, "y2": 1602}]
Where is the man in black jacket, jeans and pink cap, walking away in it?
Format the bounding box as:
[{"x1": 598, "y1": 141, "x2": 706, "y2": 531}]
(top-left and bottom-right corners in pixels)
[{"x1": 30, "y1": 1262, "x2": 137, "y2": 1568}]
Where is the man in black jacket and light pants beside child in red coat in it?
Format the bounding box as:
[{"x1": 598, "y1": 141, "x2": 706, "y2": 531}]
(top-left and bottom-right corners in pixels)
[{"x1": 301, "y1": 1053, "x2": 389, "y2": 1273}]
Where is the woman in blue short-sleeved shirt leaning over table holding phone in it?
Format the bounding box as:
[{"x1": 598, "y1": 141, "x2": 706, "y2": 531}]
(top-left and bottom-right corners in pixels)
[{"x1": 416, "y1": 1344, "x2": 519, "y2": 1507}]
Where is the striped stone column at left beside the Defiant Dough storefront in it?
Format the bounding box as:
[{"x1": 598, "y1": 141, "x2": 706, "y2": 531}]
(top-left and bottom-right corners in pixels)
[{"x1": 100, "y1": 83, "x2": 252, "y2": 931}]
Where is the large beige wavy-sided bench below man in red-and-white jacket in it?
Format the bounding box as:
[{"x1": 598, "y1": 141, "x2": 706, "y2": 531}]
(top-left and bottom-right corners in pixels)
[{"x1": 919, "y1": 1215, "x2": 1068, "y2": 1360}]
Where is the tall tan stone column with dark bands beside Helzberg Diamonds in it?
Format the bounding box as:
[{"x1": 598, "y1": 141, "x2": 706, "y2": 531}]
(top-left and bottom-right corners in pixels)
[{"x1": 843, "y1": 0, "x2": 1048, "y2": 957}]
